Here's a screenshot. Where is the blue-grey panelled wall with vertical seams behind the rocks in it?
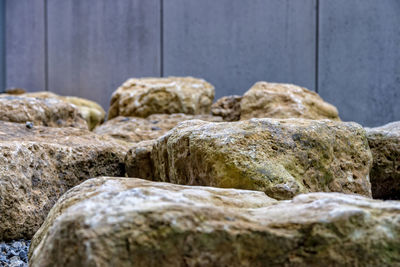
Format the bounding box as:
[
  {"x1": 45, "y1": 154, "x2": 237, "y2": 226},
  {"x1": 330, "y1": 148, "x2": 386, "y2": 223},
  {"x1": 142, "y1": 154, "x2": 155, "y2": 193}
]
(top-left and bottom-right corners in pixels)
[{"x1": 0, "y1": 0, "x2": 400, "y2": 126}]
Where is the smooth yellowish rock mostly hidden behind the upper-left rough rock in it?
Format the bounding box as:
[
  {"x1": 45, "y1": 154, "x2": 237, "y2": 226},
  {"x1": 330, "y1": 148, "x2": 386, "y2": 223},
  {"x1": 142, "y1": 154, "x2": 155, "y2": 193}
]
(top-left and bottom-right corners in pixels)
[{"x1": 25, "y1": 91, "x2": 106, "y2": 130}]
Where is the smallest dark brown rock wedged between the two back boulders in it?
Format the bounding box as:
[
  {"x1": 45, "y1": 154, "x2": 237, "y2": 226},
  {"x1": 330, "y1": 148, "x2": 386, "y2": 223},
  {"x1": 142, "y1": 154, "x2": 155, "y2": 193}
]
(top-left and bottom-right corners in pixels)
[{"x1": 211, "y1": 95, "x2": 242, "y2": 121}]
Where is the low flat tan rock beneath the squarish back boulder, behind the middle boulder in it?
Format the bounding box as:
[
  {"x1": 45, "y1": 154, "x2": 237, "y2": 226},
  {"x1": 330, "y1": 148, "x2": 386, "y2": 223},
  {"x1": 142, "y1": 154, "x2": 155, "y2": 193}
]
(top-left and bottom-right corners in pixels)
[{"x1": 94, "y1": 113, "x2": 222, "y2": 146}]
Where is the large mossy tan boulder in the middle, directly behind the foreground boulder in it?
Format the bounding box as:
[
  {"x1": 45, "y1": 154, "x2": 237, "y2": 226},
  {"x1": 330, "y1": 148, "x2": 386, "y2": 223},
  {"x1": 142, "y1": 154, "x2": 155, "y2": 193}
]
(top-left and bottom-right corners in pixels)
[{"x1": 126, "y1": 119, "x2": 372, "y2": 199}]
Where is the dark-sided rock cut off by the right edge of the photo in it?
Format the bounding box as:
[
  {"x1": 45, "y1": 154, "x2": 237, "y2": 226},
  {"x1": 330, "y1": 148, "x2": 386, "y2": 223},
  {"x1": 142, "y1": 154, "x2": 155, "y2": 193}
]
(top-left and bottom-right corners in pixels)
[{"x1": 366, "y1": 122, "x2": 400, "y2": 199}]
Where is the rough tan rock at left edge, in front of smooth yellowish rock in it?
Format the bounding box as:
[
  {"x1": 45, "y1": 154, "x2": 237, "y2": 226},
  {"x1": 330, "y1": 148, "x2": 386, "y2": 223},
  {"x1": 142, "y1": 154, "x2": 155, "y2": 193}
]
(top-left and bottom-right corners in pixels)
[{"x1": 0, "y1": 95, "x2": 88, "y2": 129}]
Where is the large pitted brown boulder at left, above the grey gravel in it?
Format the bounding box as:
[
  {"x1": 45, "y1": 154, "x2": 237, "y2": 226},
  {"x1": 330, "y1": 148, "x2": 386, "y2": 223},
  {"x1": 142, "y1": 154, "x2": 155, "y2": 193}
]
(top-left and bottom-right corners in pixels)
[{"x1": 0, "y1": 122, "x2": 128, "y2": 240}]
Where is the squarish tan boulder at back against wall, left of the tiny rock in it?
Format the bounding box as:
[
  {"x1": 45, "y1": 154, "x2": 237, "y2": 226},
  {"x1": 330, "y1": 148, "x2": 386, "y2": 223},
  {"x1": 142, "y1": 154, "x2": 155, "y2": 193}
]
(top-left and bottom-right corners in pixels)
[{"x1": 108, "y1": 77, "x2": 214, "y2": 119}]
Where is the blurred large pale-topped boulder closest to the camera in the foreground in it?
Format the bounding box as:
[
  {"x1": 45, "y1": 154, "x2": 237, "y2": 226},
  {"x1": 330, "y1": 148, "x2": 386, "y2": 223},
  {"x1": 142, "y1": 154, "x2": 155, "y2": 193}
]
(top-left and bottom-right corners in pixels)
[{"x1": 30, "y1": 178, "x2": 400, "y2": 267}]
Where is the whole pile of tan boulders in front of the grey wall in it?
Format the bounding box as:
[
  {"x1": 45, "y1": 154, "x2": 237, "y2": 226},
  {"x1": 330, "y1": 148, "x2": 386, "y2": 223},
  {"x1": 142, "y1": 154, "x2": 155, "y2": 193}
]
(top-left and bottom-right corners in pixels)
[{"x1": 0, "y1": 77, "x2": 400, "y2": 266}]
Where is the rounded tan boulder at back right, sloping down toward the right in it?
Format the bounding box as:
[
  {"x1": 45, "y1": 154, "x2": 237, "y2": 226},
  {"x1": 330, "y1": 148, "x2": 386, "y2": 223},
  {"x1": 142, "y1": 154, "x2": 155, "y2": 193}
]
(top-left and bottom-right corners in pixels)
[{"x1": 240, "y1": 82, "x2": 340, "y2": 120}]
